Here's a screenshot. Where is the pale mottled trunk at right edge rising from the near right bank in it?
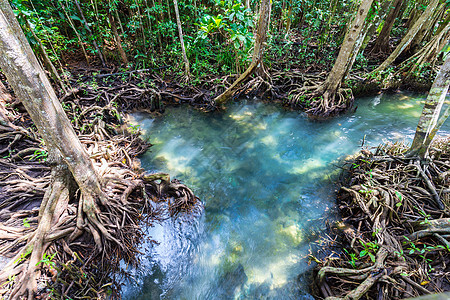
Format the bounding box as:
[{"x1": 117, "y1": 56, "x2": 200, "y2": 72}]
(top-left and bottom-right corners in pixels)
[{"x1": 408, "y1": 55, "x2": 450, "y2": 159}]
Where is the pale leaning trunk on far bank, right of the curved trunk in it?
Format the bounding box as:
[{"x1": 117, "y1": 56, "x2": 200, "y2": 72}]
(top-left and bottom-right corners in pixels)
[{"x1": 310, "y1": 0, "x2": 373, "y2": 115}]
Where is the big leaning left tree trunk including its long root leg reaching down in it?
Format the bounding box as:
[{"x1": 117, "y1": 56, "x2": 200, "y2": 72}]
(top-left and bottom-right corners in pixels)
[{"x1": 0, "y1": 0, "x2": 106, "y2": 298}]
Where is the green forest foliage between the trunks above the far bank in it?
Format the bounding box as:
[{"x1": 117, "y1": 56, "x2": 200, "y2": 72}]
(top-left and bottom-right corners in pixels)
[{"x1": 11, "y1": 0, "x2": 450, "y2": 77}]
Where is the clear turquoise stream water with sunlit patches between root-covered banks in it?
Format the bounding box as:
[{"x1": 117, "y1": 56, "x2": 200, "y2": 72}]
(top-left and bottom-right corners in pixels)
[{"x1": 123, "y1": 94, "x2": 450, "y2": 299}]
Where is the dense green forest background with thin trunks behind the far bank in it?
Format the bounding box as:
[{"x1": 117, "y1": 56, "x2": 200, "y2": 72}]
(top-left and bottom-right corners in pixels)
[{"x1": 11, "y1": 0, "x2": 450, "y2": 108}]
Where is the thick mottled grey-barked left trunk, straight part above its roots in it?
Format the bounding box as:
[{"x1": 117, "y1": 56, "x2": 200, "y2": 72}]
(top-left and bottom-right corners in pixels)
[{"x1": 0, "y1": 0, "x2": 100, "y2": 196}]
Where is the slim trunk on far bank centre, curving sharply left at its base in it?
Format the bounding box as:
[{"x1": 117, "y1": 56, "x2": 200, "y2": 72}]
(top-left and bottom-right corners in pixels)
[{"x1": 214, "y1": 0, "x2": 272, "y2": 107}]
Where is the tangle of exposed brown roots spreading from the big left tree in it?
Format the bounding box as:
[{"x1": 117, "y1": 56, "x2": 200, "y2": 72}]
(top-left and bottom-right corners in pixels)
[{"x1": 0, "y1": 78, "x2": 201, "y2": 299}]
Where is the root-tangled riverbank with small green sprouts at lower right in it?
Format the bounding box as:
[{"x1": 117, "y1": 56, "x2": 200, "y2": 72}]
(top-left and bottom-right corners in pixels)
[{"x1": 311, "y1": 138, "x2": 450, "y2": 299}]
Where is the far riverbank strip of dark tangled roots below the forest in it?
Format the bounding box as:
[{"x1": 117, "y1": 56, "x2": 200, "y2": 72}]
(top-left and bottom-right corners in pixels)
[{"x1": 61, "y1": 58, "x2": 432, "y2": 117}]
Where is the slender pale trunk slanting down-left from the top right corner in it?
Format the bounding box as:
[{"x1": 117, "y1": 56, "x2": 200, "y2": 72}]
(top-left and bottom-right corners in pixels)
[{"x1": 373, "y1": 0, "x2": 439, "y2": 73}]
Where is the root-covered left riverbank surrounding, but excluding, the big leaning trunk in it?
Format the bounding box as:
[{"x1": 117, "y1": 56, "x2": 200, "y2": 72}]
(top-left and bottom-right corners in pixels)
[{"x1": 0, "y1": 78, "x2": 201, "y2": 298}]
